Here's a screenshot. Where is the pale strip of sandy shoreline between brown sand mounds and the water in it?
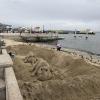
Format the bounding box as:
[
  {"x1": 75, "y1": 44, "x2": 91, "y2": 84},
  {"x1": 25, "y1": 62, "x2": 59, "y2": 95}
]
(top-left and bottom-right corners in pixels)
[{"x1": 4, "y1": 39, "x2": 100, "y2": 66}]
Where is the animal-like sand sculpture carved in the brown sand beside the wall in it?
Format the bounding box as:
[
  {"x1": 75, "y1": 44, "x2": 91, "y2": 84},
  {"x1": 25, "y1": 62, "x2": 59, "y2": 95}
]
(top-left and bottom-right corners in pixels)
[{"x1": 24, "y1": 52, "x2": 52, "y2": 81}]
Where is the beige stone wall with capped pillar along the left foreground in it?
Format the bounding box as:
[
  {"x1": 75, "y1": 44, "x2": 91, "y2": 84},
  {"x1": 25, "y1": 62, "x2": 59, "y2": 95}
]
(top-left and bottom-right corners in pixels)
[{"x1": 0, "y1": 49, "x2": 23, "y2": 100}]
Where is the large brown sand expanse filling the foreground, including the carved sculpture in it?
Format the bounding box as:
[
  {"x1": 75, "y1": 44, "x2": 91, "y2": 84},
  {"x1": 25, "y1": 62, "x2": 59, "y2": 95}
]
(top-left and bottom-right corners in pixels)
[{"x1": 7, "y1": 45, "x2": 100, "y2": 100}]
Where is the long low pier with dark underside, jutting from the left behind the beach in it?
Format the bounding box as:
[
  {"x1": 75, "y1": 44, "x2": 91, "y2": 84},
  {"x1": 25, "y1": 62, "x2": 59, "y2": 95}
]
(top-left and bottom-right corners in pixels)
[{"x1": 0, "y1": 33, "x2": 63, "y2": 42}]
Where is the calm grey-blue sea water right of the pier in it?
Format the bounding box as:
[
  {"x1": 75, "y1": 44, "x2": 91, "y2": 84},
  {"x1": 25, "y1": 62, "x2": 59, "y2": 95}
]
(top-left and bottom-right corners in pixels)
[{"x1": 58, "y1": 33, "x2": 100, "y2": 55}]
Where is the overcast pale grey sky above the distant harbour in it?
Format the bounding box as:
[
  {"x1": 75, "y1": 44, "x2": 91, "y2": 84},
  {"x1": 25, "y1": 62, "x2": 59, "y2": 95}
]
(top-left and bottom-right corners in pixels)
[{"x1": 0, "y1": 0, "x2": 100, "y2": 31}]
